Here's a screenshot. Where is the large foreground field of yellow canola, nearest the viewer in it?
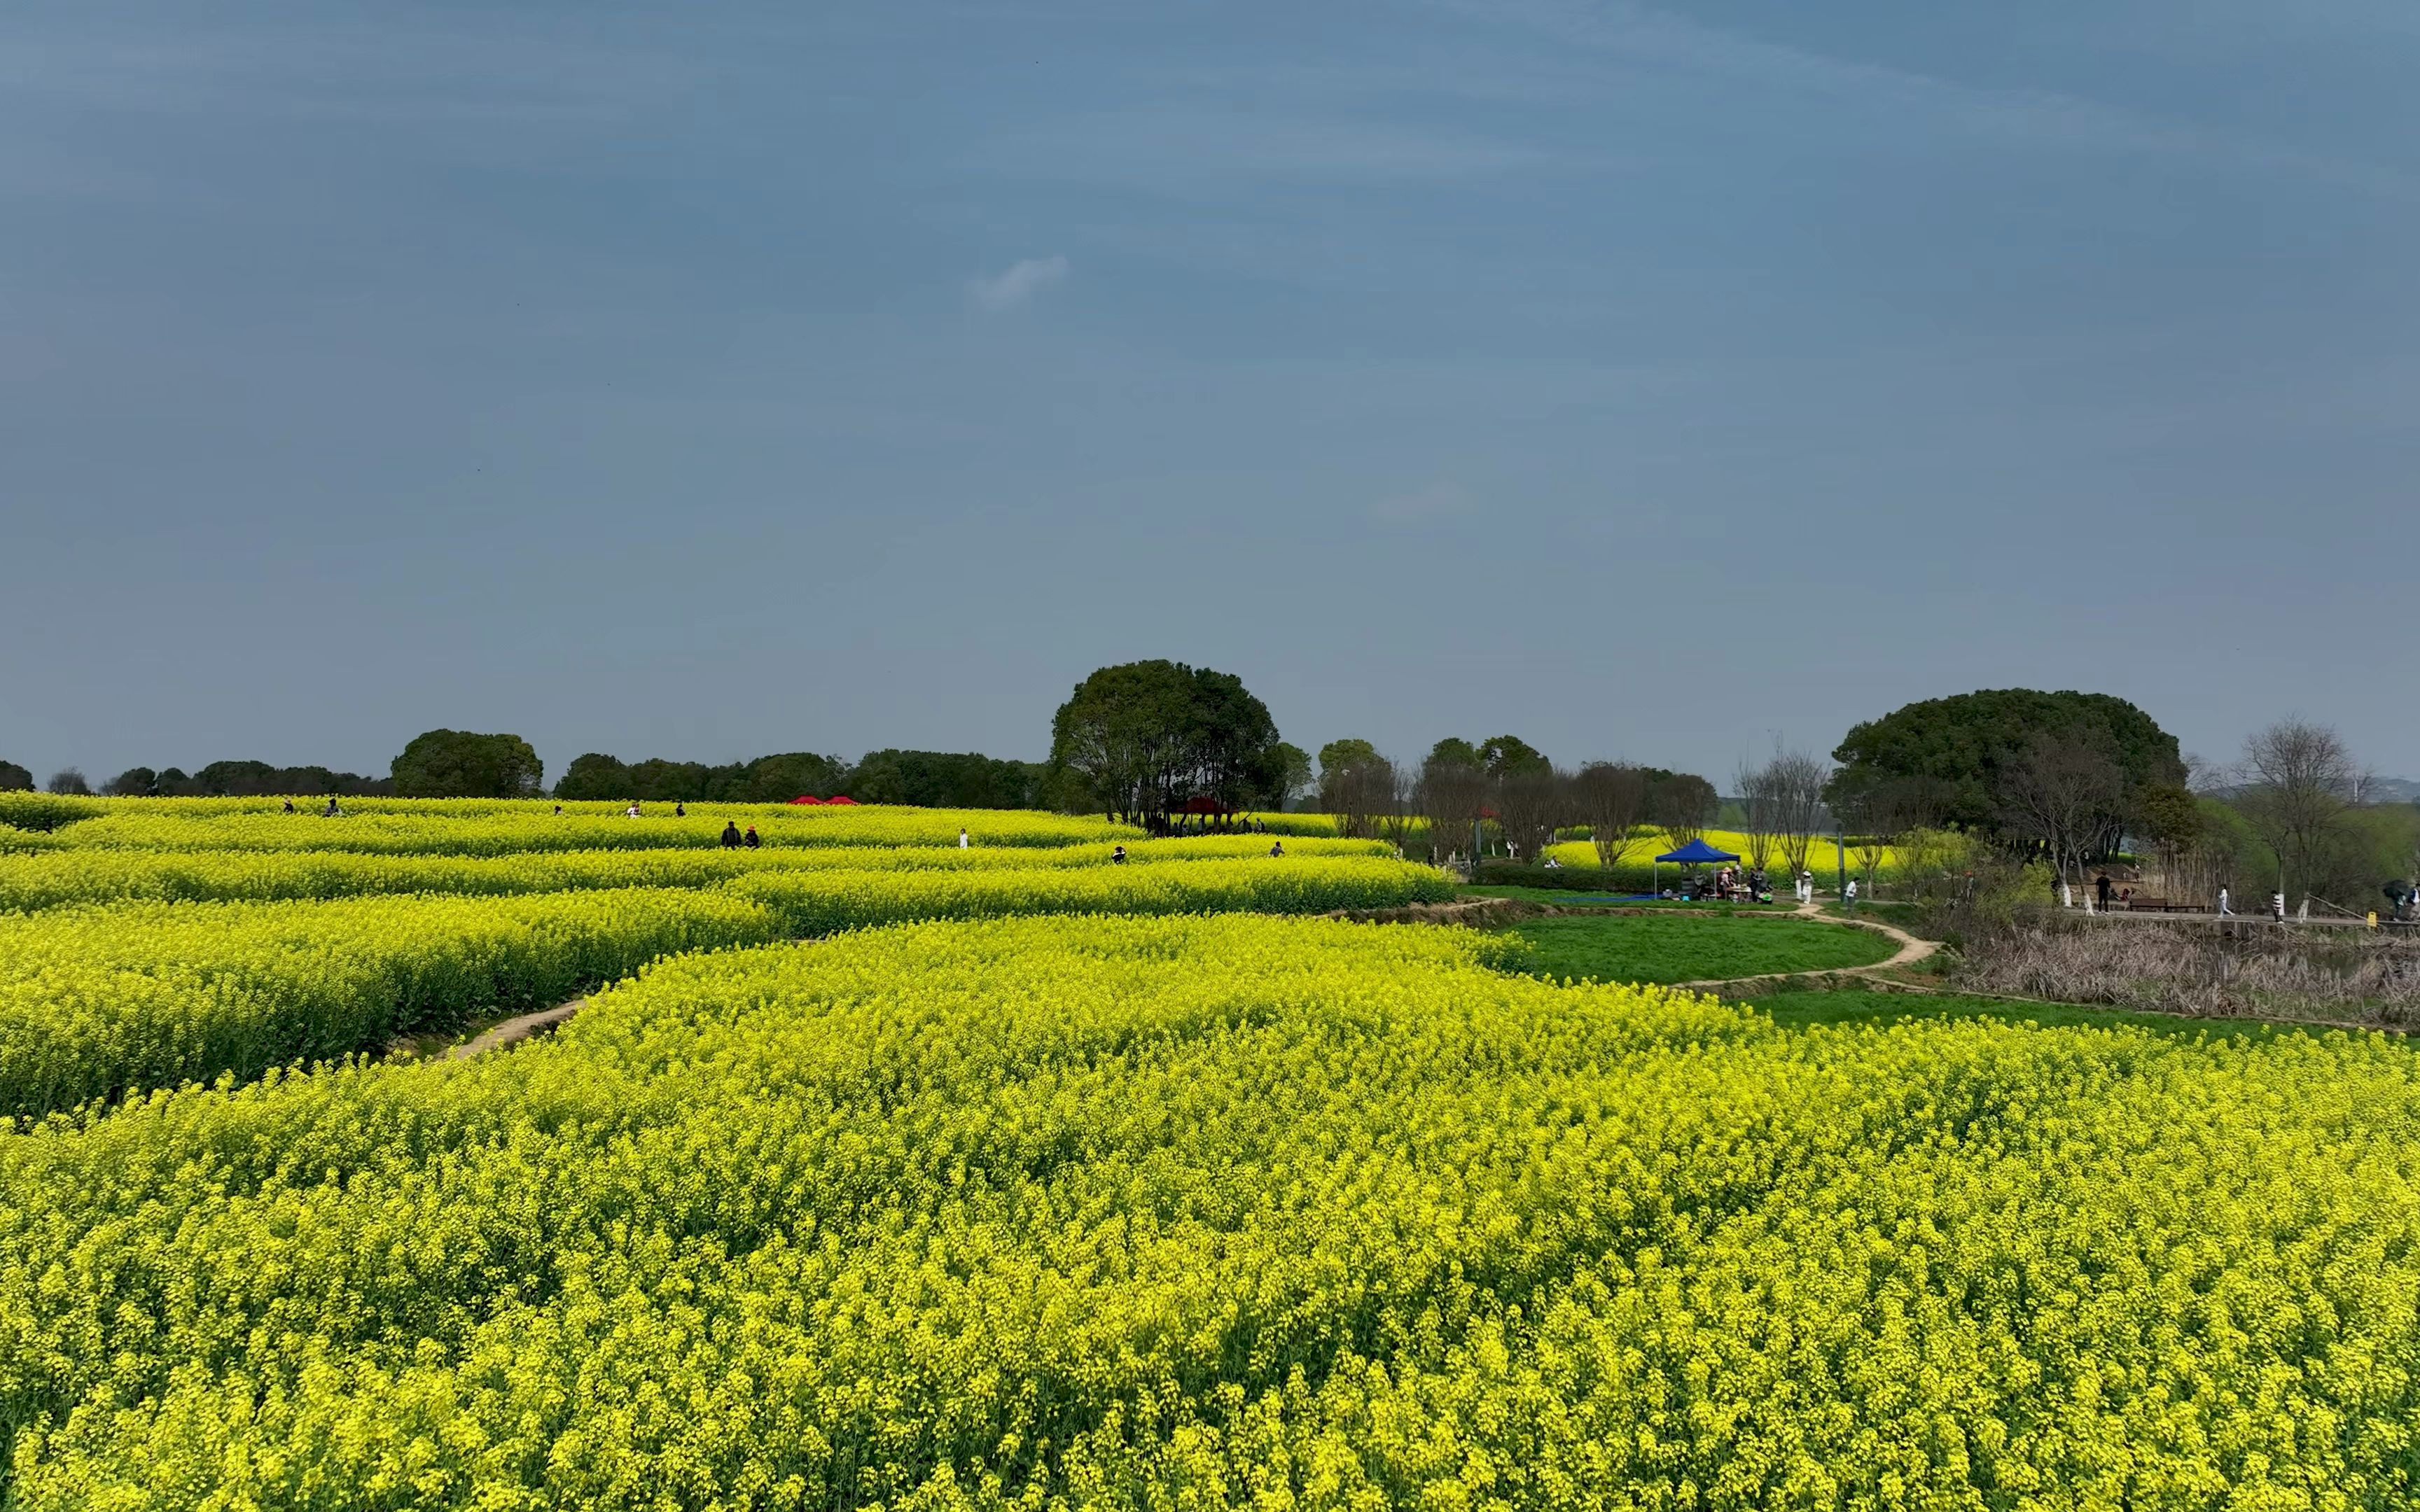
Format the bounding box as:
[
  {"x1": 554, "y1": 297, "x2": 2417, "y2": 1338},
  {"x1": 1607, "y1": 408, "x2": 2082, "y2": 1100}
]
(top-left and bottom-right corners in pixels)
[{"x1": 0, "y1": 914, "x2": 2420, "y2": 1512}]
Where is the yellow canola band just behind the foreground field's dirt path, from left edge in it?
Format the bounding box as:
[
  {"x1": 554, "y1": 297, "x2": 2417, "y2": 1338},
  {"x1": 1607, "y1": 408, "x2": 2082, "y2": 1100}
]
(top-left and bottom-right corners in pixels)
[{"x1": 0, "y1": 842, "x2": 1452, "y2": 1115}]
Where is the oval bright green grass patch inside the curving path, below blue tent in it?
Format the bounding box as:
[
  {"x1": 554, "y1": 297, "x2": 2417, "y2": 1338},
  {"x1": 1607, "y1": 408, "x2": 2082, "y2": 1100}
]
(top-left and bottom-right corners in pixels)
[{"x1": 1508, "y1": 914, "x2": 1898, "y2": 982}]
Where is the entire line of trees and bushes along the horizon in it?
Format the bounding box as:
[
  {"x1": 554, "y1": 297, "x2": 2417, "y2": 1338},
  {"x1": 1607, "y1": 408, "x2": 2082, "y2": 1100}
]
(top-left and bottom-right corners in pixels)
[{"x1": 28, "y1": 660, "x2": 2420, "y2": 912}]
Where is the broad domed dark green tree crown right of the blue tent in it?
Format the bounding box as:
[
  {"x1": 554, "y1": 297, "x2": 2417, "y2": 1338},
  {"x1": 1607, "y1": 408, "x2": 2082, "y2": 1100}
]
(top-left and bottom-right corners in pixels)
[{"x1": 1825, "y1": 687, "x2": 2185, "y2": 839}]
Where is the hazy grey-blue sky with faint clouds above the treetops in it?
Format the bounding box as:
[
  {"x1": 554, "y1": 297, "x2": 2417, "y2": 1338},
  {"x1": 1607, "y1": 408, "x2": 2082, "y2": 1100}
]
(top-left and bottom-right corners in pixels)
[{"x1": 0, "y1": 0, "x2": 2420, "y2": 779}]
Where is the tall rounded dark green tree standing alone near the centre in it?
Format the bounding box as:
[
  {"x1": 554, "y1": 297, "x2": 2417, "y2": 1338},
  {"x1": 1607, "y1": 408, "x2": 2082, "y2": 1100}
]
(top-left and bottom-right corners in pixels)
[{"x1": 1050, "y1": 660, "x2": 1283, "y2": 825}]
